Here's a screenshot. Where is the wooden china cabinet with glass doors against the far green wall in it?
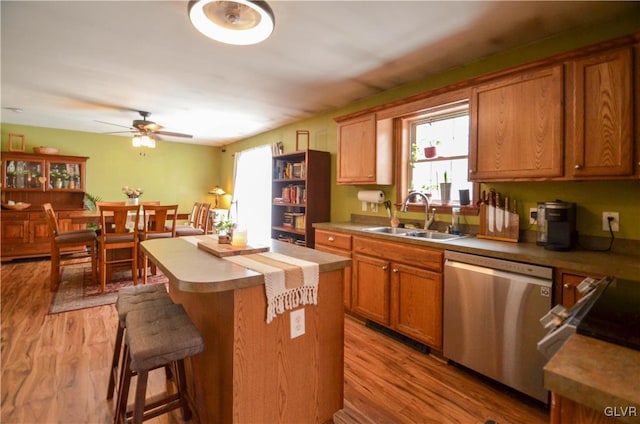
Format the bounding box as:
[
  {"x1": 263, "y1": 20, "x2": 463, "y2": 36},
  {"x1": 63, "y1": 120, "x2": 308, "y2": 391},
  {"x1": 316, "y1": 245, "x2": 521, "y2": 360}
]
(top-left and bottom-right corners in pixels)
[{"x1": 0, "y1": 152, "x2": 89, "y2": 261}]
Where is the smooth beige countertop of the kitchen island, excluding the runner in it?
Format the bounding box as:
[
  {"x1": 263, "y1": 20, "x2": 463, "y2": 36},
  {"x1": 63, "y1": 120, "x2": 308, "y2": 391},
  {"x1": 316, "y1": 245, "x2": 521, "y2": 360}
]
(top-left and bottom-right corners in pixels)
[{"x1": 140, "y1": 236, "x2": 351, "y2": 292}]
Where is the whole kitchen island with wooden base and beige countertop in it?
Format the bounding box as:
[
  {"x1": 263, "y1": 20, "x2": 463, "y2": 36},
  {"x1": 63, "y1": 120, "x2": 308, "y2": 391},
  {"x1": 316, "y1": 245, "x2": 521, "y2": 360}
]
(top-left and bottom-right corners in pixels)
[{"x1": 141, "y1": 236, "x2": 351, "y2": 423}]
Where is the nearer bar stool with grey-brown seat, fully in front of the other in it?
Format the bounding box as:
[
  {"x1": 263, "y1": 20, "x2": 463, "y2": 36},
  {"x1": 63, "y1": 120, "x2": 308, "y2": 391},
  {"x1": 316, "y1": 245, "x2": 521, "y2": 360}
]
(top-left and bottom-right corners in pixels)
[{"x1": 114, "y1": 304, "x2": 204, "y2": 424}]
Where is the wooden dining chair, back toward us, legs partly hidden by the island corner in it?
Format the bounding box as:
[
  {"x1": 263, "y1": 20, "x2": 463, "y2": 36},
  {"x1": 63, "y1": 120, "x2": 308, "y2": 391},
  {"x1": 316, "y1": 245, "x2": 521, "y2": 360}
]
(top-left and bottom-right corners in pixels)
[{"x1": 139, "y1": 205, "x2": 178, "y2": 284}]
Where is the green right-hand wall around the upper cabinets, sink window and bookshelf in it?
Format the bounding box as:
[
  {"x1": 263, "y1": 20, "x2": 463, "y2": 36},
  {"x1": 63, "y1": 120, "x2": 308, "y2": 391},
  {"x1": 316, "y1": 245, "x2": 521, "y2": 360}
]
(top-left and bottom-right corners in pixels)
[{"x1": 220, "y1": 8, "x2": 640, "y2": 240}]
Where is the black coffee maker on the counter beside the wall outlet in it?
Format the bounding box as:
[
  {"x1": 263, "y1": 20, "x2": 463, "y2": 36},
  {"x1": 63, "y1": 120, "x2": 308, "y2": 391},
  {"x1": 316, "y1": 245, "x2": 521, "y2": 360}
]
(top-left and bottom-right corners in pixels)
[{"x1": 544, "y1": 200, "x2": 577, "y2": 251}]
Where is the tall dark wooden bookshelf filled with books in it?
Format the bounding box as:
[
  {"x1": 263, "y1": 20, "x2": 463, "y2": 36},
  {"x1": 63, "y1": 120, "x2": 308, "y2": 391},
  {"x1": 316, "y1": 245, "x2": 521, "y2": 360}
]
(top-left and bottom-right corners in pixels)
[{"x1": 271, "y1": 150, "x2": 331, "y2": 248}]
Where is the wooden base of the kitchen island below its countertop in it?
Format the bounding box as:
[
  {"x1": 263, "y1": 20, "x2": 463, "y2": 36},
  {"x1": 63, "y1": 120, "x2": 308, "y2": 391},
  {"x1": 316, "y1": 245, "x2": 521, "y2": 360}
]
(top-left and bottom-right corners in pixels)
[{"x1": 169, "y1": 270, "x2": 344, "y2": 423}]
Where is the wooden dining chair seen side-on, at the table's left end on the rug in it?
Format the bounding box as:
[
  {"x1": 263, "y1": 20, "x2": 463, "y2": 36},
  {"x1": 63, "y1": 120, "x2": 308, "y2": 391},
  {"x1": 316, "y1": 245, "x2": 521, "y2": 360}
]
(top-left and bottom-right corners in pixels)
[{"x1": 42, "y1": 203, "x2": 98, "y2": 291}]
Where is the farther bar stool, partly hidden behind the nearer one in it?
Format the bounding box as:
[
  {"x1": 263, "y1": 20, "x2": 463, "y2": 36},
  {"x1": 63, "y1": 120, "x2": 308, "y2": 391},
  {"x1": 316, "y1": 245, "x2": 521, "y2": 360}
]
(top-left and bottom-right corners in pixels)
[{"x1": 107, "y1": 284, "x2": 173, "y2": 399}]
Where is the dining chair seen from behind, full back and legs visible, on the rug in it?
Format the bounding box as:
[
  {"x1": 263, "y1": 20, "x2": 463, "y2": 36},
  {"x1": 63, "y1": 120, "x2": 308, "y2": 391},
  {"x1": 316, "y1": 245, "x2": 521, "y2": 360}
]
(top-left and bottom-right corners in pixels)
[{"x1": 99, "y1": 205, "x2": 140, "y2": 292}]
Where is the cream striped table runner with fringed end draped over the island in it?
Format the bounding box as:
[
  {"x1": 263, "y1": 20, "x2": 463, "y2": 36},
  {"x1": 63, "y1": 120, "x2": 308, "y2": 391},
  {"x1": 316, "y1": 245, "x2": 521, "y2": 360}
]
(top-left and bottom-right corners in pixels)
[{"x1": 222, "y1": 252, "x2": 320, "y2": 324}]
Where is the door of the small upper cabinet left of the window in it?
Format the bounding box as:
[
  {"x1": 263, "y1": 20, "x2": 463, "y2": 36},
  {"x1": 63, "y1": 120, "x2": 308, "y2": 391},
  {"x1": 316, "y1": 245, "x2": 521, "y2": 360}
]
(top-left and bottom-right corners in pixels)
[{"x1": 336, "y1": 114, "x2": 377, "y2": 184}]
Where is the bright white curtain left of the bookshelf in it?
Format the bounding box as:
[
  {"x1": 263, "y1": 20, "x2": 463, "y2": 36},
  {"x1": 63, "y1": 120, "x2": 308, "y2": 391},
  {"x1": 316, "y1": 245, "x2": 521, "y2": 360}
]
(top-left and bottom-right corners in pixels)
[{"x1": 230, "y1": 145, "x2": 271, "y2": 244}]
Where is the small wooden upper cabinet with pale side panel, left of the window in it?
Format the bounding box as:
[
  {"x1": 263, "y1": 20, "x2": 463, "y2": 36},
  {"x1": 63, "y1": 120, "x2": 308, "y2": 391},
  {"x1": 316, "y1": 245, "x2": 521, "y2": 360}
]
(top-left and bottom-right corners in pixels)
[{"x1": 336, "y1": 113, "x2": 393, "y2": 185}]
